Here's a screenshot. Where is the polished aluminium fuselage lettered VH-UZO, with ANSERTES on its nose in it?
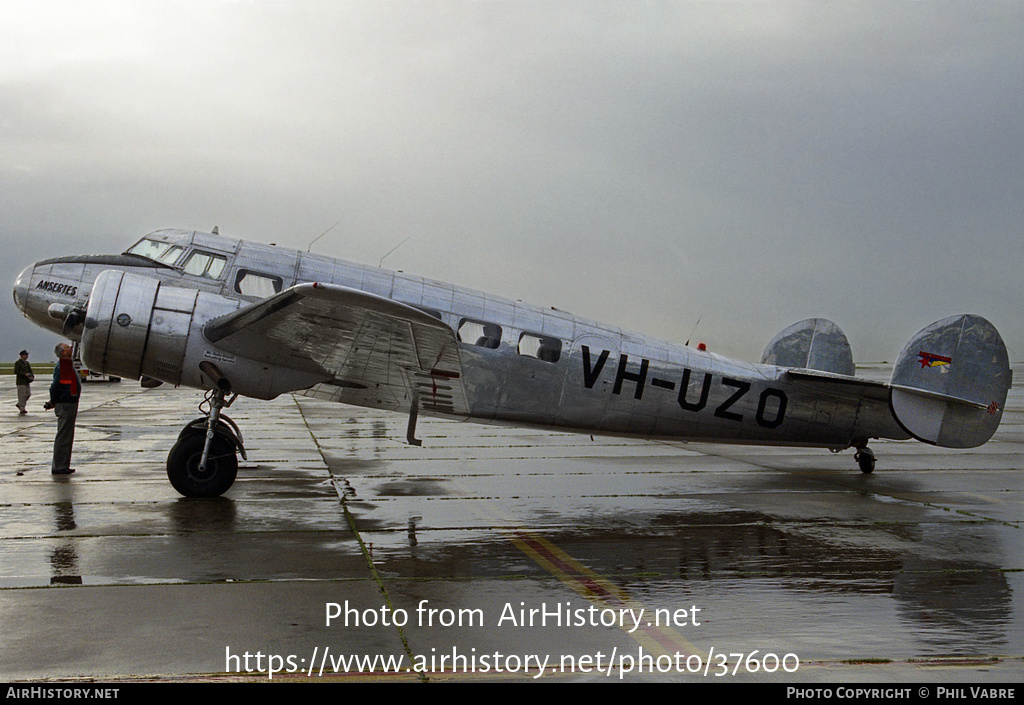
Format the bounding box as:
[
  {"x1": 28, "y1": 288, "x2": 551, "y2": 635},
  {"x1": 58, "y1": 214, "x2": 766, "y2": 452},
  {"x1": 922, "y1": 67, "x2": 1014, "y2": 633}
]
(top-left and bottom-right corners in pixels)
[{"x1": 14, "y1": 231, "x2": 907, "y2": 449}]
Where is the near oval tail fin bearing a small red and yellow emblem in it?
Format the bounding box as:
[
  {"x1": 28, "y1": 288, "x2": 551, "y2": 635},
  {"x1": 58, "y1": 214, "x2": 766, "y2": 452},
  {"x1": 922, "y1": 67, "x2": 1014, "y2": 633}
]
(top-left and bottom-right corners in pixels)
[{"x1": 889, "y1": 315, "x2": 1012, "y2": 448}]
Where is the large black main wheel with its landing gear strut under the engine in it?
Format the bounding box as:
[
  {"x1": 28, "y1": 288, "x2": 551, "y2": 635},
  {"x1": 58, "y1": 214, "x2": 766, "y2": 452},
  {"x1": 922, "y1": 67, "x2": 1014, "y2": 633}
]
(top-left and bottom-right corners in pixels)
[{"x1": 167, "y1": 380, "x2": 246, "y2": 497}]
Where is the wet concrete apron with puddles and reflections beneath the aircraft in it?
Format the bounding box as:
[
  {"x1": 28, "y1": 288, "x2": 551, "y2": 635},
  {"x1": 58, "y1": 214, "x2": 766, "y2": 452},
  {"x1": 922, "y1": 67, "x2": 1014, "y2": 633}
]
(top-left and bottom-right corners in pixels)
[{"x1": 0, "y1": 370, "x2": 1024, "y2": 680}]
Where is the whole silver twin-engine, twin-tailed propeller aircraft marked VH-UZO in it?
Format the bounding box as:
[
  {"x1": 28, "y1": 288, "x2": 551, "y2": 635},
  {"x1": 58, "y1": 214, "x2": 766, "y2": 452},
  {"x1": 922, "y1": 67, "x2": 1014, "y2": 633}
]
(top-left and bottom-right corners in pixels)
[{"x1": 14, "y1": 229, "x2": 1011, "y2": 497}]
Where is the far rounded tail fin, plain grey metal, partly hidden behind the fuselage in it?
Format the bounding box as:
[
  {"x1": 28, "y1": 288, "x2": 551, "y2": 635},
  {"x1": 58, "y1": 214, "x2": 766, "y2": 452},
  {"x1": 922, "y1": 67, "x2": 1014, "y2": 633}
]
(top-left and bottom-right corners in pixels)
[{"x1": 761, "y1": 319, "x2": 855, "y2": 376}]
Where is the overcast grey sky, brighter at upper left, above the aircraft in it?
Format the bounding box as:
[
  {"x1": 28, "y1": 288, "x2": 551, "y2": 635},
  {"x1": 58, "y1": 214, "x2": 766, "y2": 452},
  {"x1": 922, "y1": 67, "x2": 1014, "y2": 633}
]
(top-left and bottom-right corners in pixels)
[{"x1": 0, "y1": 0, "x2": 1024, "y2": 361}]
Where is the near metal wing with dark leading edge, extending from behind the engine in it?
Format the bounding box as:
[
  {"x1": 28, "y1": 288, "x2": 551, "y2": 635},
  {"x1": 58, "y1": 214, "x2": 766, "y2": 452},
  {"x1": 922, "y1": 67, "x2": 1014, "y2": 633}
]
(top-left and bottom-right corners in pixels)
[{"x1": 204, "y1": 284, "x2": 469, "y2": 416}]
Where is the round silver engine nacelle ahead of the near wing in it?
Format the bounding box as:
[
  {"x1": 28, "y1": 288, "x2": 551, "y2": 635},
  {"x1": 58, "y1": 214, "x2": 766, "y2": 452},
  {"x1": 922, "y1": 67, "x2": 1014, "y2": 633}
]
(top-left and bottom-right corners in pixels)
[{"x1": 81, "y1": 269, "x2": 326, "y2": 399}]
